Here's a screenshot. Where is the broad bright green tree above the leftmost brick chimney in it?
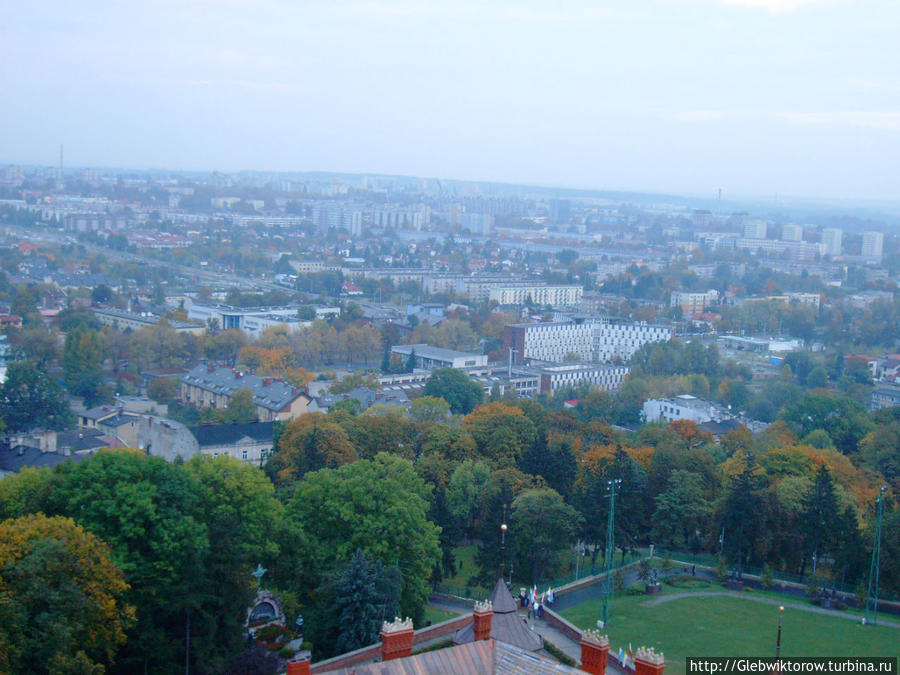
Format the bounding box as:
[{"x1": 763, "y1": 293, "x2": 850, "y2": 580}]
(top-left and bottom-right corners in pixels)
[{"x1": 288, "y1": 453, "x2": 441, "y2": 616}]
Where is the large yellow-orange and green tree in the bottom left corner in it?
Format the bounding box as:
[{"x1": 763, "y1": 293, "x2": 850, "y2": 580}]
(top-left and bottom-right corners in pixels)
[{"x1": 0, "y1": 514, "x2": 134, "y2": 673}]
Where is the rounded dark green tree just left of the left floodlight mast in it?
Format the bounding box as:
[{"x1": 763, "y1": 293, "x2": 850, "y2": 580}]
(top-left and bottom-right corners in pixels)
[{"x1": 510, "y1": 488, "x2": 581, "y2": 584}]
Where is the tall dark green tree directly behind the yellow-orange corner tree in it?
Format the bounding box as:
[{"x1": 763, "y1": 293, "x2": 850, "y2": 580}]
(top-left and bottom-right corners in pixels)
[{"x1": 41, "y1": 450, "x2": 210, "y2": 674}]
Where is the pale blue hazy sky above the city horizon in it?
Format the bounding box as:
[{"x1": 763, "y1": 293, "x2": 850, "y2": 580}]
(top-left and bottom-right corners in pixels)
[{"x1": 0, "y1": 0, "x2": 900, "y2": 200}]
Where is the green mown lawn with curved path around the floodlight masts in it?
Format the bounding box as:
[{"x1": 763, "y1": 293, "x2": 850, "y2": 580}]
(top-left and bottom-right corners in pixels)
[{"x1": 561, "y1": 584, "x2": 900, "y2": 675}]
